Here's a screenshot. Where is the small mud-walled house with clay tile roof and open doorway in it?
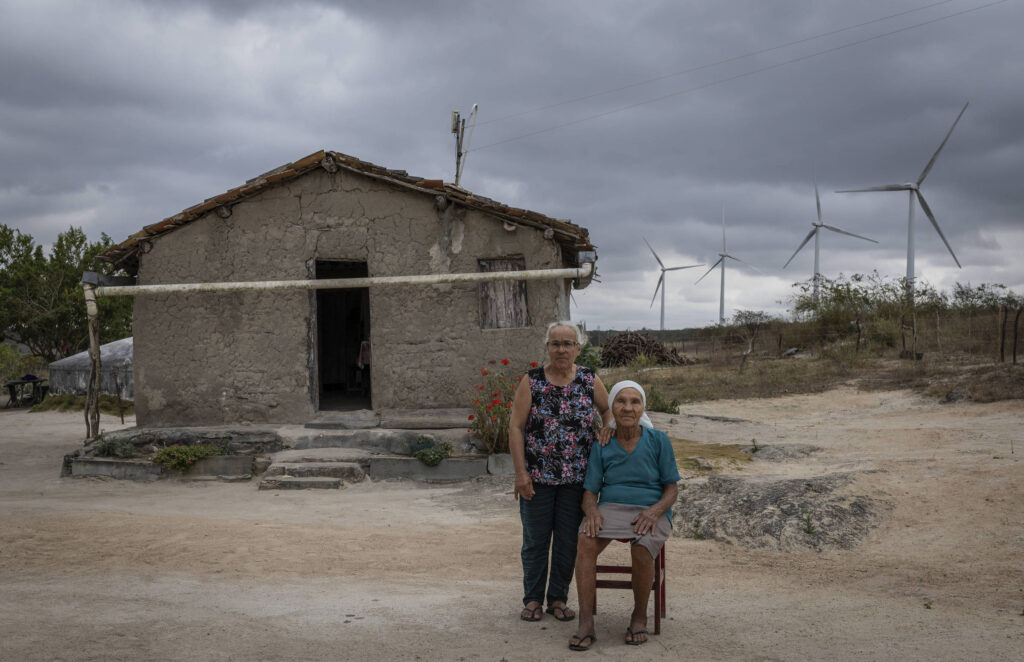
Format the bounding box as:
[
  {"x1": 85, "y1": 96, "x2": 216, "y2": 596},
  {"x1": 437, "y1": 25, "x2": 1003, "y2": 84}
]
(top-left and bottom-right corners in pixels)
[{"x1": 101, "y1": 151, "x2": 595, "y2": 426}]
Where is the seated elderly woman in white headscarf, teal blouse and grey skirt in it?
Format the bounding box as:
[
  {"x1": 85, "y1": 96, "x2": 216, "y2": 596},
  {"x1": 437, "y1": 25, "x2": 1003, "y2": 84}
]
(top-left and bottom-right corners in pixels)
[{"x1": 569, "y1": 381, "x2": 679, "y2": 651}]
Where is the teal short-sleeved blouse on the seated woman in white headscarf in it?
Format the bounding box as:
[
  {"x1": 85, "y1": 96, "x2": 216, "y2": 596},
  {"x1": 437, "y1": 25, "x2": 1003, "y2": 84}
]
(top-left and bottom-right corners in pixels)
[{"x1": 583, "y1": 427, "x2": 679, "y2": 521}]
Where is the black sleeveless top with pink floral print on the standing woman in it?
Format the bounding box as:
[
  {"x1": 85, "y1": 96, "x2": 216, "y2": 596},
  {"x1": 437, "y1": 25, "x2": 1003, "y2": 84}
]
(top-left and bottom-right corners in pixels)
[{"x1": 526, "y1": 366, "x2": 594, "y2": 485}]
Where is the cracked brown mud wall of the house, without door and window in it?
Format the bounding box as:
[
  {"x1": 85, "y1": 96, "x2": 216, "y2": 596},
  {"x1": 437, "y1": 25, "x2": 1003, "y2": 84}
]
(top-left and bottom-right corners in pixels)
[{"x1": 134, "y1": 164, "x2": 568, "y2": 425}]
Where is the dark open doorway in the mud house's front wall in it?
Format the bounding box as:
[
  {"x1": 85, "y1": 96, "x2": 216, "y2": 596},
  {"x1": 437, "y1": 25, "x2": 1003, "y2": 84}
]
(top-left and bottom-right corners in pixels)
[{"x1": 316, "y1": 260, "x2": 372, "y2": 411}]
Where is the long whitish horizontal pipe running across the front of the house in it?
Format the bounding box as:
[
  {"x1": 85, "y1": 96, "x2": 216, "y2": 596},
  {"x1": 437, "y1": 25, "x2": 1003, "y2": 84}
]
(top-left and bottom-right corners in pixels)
[{"x1": 95, "y1": 262, "x2": 594, "y2": 296}]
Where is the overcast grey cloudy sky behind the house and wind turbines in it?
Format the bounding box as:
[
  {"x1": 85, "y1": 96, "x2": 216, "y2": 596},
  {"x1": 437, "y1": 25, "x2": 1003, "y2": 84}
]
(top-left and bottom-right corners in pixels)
[{"x1": 0, "y1": 0, "x2": 1024, "y2": 329}]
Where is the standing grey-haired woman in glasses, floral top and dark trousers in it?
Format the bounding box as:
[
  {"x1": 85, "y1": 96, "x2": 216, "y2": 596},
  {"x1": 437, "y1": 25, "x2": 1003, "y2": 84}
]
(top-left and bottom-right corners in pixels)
[{"x1": 509, "y1": 322, "x2": 611, "y2": 621}]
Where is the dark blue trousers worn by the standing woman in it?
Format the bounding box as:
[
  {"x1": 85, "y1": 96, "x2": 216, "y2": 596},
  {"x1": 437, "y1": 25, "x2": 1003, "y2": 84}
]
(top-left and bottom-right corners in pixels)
[{"x1": 519, "y1": 483, "x2": 583, "y2": 607}]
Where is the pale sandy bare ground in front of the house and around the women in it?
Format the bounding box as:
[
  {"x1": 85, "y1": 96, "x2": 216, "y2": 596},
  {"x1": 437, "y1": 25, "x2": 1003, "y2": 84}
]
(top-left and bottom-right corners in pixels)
[{"x1": 0, "y1": 388, "x2": 1024, "y2": 661}]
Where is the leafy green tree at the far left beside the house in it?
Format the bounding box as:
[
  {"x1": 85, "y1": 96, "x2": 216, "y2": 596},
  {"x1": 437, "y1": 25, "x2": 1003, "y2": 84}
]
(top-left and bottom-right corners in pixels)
[{"x1": 0, "y1": 224, "x2": 132, "y2": 362}]
